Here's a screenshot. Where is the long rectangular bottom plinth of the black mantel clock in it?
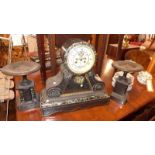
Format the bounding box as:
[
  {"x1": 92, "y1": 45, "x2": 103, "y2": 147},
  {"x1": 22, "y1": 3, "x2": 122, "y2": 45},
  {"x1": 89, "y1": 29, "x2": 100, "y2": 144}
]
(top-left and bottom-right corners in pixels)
[{"x1": 41, "y1": 90, "x2": 110, "y2": 116}]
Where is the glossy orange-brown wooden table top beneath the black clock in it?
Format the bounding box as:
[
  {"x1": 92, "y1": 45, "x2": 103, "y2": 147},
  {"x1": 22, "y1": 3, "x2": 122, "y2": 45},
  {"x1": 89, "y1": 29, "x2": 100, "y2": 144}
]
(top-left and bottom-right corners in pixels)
[{"x1": 16, "y1": 56, "x2": 155, "y2": 121}]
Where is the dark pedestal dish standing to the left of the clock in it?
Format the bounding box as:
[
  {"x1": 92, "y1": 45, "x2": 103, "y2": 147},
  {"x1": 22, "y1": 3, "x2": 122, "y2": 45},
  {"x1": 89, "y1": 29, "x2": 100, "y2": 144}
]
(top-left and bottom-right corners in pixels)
[{"x1": 1, "y1": 61, "x2": 40, "y2": 111}]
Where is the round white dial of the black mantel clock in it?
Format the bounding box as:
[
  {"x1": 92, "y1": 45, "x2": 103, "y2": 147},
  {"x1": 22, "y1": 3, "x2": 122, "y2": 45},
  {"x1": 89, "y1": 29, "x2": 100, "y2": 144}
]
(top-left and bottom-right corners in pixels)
[{"x1": 67, "y1": 44, "x2": 95, "y2": 74}]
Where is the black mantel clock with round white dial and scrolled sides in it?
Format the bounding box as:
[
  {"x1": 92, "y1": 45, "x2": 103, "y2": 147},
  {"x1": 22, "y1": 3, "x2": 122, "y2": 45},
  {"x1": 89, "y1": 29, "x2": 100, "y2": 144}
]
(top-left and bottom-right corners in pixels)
[{"x1": 40, "y1": 39, "x2": 110, "y2": 116}]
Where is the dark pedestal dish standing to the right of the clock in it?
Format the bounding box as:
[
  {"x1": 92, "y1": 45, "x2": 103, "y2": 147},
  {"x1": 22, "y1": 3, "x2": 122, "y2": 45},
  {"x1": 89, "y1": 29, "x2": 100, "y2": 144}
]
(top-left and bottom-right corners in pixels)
[{"x1": 111, "y1": 60, "x2": 143, "y2": 104}]
